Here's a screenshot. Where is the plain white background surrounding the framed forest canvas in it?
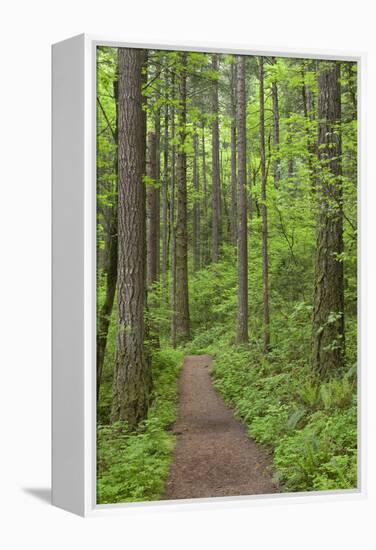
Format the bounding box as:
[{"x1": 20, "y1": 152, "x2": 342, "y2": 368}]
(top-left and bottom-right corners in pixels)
[{"x1": 0, "y1": 0, "x2": 376, "y2": 550}]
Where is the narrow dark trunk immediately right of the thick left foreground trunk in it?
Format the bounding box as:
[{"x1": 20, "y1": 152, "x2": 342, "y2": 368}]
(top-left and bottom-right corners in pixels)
[{"x1": 146, "y1": 132, "x2": 159, "y2": 287}]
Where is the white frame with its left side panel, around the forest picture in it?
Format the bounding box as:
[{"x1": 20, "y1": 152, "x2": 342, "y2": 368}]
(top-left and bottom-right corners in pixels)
[{"x1": 52, "y1": 34, "x2": 366, "y2": 516}]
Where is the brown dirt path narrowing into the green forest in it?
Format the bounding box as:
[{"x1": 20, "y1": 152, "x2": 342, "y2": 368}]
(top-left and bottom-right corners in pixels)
[{"x1": 163, "y1": 355, "x2": 277, "y2": 499}]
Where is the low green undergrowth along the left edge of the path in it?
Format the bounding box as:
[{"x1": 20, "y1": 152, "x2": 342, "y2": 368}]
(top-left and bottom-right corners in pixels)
[{"x1": 97, "y1": 349, "x2": 182, "y2": 504}]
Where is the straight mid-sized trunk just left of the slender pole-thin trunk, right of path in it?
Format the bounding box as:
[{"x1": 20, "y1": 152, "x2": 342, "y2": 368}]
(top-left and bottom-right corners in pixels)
[{"x1": 236, "y1": 56, "x2": 248, "y2": 343}]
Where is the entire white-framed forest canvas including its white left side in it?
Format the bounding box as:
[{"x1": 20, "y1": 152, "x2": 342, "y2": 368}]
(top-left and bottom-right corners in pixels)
[{"x1": 52, "y1": 35, "x2": 365, "y2": 516}]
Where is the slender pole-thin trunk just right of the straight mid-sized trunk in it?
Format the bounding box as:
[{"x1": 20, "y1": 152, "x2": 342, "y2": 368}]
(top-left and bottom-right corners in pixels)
[{"x1": 259, "y1": 57, "x2": 270, "y2": 353}]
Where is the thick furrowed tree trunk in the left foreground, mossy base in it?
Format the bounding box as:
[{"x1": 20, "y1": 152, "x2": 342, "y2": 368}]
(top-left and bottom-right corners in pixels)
[{"x1": 112, "y1": 48, "x2": 150, "y2": 429}]
